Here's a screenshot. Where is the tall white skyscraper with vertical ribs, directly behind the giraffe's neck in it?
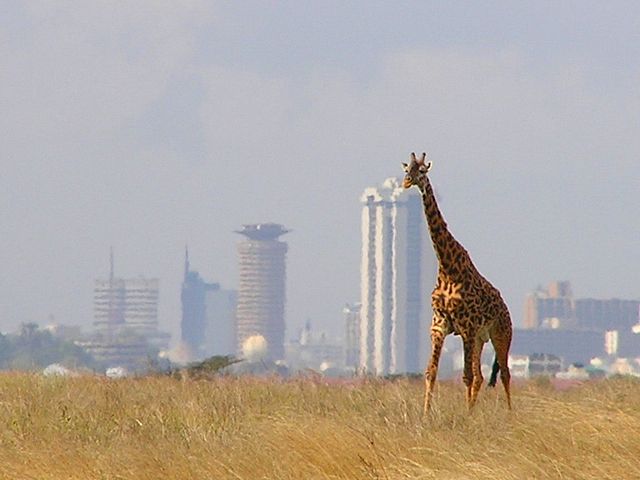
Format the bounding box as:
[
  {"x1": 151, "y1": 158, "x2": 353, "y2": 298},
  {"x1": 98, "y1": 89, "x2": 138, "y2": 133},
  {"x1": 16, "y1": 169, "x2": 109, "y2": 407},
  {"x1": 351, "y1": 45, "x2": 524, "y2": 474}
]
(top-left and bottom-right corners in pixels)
[{"x1": 360, "y1": 178, "x2": 437, "y2": 375}]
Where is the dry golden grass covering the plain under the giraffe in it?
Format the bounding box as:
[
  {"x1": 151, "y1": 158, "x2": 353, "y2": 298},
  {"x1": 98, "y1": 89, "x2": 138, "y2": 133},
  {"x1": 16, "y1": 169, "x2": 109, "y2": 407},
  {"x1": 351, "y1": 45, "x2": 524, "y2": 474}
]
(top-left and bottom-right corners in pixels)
[{"x1": 0, "y1": 373, "x2": 640, "y2": 480}]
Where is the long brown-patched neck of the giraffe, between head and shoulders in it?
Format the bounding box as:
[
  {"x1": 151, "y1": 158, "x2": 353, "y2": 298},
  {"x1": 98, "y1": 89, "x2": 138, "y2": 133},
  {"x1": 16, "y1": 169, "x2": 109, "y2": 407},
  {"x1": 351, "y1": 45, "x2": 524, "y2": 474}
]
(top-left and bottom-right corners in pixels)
[{"x1": 420, "y1": 177, "x2": 466, "y2": 275}]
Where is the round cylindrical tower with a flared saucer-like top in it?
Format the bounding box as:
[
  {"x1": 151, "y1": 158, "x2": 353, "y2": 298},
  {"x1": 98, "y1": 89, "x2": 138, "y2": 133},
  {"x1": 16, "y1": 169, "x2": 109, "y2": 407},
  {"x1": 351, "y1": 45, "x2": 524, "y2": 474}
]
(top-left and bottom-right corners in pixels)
[{"x1": 236, "y1": 223, "x2": 288, "y2": 360}]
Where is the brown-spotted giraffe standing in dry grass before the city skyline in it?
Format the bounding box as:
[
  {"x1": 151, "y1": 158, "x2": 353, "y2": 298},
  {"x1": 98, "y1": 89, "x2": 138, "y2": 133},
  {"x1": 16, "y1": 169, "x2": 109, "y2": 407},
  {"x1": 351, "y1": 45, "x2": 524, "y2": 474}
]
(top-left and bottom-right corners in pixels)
[{"x1": 403, "y1": 153, "x2": 512, "y2": 414}]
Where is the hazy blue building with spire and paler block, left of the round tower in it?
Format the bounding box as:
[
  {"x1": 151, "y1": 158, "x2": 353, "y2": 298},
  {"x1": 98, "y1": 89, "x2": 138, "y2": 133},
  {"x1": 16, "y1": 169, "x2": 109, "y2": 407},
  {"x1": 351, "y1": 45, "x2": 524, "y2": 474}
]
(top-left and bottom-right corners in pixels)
[{"x1": 180, "y1": 251, "x2": 236, "y2": 360}]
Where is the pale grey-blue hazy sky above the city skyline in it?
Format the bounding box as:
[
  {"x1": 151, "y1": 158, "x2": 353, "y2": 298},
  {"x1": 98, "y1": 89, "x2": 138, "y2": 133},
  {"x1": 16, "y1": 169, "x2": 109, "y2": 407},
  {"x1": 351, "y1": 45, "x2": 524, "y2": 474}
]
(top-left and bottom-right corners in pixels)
[{"x1": 0, "y1": 0, "x2": 640, "y2": 337}]
